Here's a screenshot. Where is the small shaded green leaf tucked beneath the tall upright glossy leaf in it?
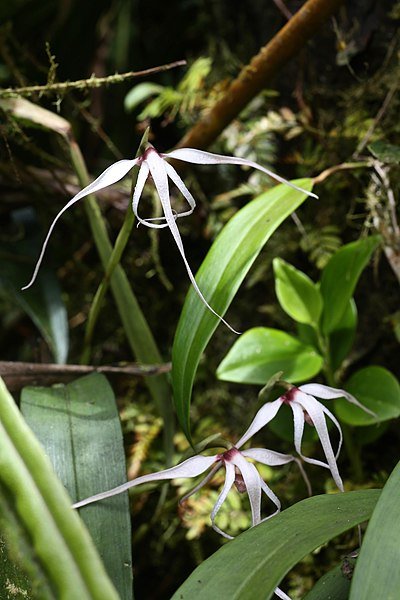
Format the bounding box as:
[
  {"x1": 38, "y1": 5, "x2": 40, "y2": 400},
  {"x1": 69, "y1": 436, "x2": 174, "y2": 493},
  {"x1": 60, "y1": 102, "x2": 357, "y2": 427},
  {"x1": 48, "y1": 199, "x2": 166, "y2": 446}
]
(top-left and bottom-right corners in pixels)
[{"x1": 329, "y1": 298, "x2": 358, "y2": 370}]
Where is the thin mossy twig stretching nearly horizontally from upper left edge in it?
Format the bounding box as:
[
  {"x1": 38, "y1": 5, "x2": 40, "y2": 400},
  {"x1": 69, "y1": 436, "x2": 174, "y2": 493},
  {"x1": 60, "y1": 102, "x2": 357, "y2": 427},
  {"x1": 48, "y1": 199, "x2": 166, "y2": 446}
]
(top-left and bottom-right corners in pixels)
[{"x1": 0, "y1": 60, "x2": 186, "y2": 97}]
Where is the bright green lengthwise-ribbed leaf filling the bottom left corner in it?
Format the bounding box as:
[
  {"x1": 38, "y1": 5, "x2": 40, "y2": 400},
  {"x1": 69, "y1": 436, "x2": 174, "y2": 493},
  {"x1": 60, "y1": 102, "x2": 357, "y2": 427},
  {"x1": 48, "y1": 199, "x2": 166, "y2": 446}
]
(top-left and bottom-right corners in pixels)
[{"x1": 0, "y1": 379, "x2": 118, "y2": 600}]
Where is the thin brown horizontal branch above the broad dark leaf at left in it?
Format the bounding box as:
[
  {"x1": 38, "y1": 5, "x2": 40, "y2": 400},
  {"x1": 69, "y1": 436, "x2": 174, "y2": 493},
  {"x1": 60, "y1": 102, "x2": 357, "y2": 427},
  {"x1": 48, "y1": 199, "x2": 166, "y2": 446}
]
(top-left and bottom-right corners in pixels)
[{"x1": 0, "y1": 361, "x2": 171, "y2": 392}]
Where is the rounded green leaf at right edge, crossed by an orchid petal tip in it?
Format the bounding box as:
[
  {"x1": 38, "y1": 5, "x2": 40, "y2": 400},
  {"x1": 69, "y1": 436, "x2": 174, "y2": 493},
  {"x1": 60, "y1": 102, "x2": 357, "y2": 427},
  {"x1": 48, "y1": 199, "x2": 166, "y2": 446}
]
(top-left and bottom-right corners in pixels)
[{"x1": 335, "y1": 366, "x2": 400, "y2": 425}]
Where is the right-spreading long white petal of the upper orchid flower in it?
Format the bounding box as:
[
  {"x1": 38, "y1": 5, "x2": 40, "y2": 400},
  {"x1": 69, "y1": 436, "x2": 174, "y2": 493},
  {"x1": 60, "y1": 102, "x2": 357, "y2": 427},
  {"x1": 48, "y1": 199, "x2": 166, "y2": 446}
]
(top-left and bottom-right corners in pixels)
[{"x1": 162, "y1": 148, "x2": 318, "y2": 198}]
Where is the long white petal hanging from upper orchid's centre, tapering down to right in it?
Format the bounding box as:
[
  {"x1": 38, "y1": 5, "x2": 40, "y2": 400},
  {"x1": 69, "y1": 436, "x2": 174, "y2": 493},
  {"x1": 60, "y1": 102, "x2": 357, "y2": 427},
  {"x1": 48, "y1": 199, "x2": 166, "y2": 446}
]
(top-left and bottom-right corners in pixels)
[{"x1": 146, "y1": 152, "x2": 240, "y2": 335}]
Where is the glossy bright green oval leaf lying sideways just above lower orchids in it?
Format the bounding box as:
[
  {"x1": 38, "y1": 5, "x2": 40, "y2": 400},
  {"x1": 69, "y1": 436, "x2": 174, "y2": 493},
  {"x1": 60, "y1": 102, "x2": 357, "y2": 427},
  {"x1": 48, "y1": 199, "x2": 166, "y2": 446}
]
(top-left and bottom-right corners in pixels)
[{"x1": 217, "y1": 327, "x2": 323, "y2": 385}]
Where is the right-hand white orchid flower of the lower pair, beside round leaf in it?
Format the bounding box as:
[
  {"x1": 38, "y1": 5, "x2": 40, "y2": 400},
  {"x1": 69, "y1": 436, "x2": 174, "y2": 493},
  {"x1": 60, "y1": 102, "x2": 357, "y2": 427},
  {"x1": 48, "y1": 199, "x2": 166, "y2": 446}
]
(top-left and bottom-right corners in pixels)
[{"x1": 234, "y1": 383, "x2": 376, "y2": 492}]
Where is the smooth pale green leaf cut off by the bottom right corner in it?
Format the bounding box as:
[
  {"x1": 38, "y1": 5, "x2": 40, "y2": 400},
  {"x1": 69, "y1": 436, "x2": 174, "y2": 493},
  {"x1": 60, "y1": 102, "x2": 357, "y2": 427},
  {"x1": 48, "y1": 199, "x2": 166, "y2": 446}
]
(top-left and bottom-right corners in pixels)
[{"x1": 350, "y1": 463, "x2": 400, "y2": 600}]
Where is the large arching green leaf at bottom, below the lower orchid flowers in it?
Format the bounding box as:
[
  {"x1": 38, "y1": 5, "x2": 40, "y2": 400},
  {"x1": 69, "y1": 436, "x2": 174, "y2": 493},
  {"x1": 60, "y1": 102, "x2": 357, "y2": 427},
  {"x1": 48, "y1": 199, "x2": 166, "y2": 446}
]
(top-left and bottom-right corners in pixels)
[{"x1": 173, "y1": 490, "x2": 382, "y2": 600}]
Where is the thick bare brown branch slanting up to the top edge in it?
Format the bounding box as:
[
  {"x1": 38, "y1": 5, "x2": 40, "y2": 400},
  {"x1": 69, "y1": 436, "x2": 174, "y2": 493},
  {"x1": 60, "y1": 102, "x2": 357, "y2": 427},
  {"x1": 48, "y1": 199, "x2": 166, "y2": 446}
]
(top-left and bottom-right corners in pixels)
[{"x1": 177, "y1": 0, "x2": 344, "y2": 148}]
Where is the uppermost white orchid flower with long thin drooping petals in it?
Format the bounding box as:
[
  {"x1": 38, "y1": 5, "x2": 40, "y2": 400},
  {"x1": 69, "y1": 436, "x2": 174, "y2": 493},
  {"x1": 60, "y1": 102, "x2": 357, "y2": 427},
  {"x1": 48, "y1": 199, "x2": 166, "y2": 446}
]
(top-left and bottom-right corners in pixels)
[{"x1": 22, "y1": 144, "x2": 318, "y2": 333}]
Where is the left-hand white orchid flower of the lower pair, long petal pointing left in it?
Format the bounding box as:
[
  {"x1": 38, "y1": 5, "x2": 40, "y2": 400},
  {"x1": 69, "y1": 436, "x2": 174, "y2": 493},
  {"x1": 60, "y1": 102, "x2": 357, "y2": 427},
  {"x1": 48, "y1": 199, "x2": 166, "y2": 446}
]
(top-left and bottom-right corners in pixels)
[{"x1": 73, "y1": 431, "x2": 311, "y2": 539}]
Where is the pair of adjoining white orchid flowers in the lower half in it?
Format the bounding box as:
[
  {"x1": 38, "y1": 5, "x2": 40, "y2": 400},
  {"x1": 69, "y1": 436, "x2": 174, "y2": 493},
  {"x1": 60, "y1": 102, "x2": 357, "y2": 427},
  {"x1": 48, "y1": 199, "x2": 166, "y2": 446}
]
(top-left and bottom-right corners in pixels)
[{"x1": 73, "y1": 383, "x2": 375, "y2": 600}]
